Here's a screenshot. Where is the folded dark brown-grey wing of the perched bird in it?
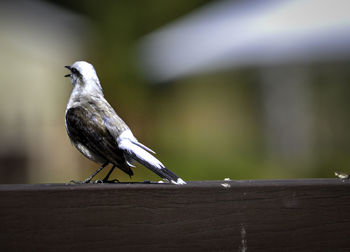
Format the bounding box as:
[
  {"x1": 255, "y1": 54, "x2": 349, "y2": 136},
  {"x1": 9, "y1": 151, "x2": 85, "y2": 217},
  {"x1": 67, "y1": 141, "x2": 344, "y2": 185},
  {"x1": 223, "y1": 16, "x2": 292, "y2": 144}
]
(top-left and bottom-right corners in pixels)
[{"x1": 66, "y1": 106, "x2": 133, "y2": 176}]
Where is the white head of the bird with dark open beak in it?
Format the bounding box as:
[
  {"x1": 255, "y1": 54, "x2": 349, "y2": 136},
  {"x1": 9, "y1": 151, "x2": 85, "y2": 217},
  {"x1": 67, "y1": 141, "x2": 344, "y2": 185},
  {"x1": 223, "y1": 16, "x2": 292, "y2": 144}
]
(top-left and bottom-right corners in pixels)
[{"x1": 65, "y1": 61, "x2": 102, "y2": 91}]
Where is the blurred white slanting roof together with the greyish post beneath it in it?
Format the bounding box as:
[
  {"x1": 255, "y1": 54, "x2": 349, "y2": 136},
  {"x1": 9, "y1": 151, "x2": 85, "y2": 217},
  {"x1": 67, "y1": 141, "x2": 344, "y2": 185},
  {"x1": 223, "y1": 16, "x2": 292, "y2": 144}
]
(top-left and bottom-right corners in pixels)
[{"x1": 138, "y1": 0, "x2": 350, "y2": 169}]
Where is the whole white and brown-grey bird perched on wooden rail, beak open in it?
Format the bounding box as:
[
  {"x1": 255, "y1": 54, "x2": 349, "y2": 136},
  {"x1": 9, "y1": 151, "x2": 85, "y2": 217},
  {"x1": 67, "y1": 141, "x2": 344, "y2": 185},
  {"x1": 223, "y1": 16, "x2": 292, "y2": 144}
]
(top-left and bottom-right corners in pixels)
[{"x1": 65, "y1": 61, "x2": 186, "y2": 184}]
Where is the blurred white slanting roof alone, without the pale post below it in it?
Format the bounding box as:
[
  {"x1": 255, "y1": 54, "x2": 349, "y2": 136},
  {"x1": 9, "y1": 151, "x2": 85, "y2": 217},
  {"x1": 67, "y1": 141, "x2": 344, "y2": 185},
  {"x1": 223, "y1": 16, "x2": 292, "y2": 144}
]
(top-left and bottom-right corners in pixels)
[{"x1": 139, "y1": 0, "x2": 350, "y2": 82}]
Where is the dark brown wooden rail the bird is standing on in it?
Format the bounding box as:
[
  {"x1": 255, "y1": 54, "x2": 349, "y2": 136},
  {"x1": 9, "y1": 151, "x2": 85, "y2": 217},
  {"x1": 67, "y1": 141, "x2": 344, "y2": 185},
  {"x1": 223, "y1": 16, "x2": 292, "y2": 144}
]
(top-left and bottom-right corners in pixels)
[{"x1": 0, "y1": 179, "x2": 350, "y2": 251}]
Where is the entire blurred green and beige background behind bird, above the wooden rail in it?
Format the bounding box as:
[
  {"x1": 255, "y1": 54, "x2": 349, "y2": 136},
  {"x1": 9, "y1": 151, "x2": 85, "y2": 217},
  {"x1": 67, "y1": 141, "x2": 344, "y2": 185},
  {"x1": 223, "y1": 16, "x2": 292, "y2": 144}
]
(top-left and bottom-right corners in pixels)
[{"x1": 0, "y1": 0, "x2": 350, "y2": 183}]
